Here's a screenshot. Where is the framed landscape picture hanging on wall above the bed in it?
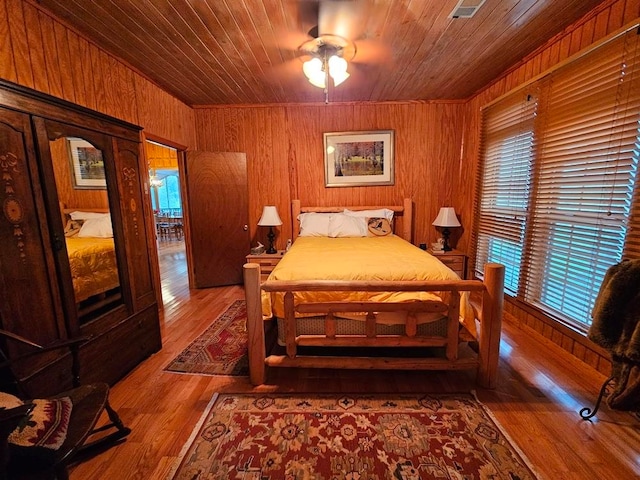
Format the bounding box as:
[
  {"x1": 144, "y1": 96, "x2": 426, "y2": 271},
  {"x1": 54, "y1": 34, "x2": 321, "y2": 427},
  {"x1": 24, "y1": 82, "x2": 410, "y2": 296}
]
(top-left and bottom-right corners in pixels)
[{"x1": 324, "y1": 130, "x2": 393, "y2": 187}]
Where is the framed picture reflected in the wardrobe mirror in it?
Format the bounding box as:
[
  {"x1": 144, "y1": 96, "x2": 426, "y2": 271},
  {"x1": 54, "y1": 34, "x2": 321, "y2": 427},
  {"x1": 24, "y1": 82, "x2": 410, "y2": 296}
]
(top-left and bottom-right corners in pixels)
[{"x1": 67, "y1": 138, "x2": 107, "y2": 190}]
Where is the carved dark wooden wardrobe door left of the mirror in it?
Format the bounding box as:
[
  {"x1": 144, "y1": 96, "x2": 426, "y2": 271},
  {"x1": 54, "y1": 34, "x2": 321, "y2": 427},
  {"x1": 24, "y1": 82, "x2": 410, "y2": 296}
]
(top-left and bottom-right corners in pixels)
[{"x1": 0, "y1": 108, "x2": 67, "y2": 344}]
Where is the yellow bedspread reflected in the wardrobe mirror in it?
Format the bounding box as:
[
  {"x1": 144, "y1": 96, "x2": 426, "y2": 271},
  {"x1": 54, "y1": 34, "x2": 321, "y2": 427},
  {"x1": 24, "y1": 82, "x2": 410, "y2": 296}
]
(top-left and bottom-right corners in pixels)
[{"x1": 66, "y1": 237, "x2": 120, "y2": 302}]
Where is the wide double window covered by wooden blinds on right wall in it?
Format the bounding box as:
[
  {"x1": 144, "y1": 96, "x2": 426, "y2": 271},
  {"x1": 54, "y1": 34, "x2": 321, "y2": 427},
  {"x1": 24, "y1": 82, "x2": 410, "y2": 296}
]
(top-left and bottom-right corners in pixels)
[{"x1": 475, "y1": 30, "x2": 640, "y2": 331}]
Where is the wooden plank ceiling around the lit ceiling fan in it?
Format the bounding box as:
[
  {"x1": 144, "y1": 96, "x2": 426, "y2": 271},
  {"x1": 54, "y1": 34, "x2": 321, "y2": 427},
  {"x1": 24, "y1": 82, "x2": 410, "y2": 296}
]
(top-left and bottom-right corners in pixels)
[{"x1": 38, "y1": 0, "x2": 606, "y2": 106}]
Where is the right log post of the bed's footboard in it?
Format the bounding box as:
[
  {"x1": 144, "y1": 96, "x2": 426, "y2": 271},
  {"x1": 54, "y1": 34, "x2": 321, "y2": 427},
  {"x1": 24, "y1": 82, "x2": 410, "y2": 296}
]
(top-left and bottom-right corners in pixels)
[{"x1": 478, "y1": 263, "x2": 504, "y2": 388}]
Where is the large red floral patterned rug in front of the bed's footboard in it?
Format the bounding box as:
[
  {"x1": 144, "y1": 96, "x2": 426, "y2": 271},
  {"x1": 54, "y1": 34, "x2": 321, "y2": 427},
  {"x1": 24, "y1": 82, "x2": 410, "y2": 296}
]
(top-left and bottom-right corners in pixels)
[{"x1": 169, "y1": 394, "x2": 536, "y2": 480}]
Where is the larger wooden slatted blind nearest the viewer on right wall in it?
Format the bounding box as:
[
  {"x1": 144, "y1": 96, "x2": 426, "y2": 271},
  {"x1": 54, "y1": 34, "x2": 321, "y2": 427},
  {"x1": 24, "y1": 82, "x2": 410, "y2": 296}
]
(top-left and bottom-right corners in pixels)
[{"x1": 524, "y1": 31, "x2": 640, "y2": 325}]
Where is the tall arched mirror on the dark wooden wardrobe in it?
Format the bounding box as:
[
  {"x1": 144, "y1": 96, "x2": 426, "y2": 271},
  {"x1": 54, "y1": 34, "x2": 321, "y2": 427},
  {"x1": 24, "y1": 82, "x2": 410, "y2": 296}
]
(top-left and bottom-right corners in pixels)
[{"x1": 49, "y1": 136, "x2": 122, "y2": 323}]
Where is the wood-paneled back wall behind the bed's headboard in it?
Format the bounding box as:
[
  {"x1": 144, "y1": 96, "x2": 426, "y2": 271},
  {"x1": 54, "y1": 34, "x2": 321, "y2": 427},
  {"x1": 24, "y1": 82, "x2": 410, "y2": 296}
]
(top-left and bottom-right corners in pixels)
[{"x1": 196, "y1": 102, "x2": 472, "y2": 248}]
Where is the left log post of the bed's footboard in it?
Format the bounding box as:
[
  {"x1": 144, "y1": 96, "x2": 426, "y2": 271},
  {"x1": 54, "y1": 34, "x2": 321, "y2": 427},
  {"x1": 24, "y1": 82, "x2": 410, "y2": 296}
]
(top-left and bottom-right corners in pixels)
[{"x1": 242, "y1": 263, "x2": 267, "y2": 385}]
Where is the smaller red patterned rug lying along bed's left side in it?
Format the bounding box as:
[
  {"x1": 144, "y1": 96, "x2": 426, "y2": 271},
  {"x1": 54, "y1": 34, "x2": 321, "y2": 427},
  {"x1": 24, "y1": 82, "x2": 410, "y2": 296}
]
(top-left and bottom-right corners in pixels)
[{"x1": 165, "y1": 300, "x2": 249, "y2": 376}]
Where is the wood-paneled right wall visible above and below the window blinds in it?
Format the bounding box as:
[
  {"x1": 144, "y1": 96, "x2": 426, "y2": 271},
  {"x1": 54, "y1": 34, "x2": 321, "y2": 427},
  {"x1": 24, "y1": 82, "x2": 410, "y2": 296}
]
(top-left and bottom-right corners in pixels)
[{"x1": 464, "y1": 0, "x2": 640, "y2": 375}]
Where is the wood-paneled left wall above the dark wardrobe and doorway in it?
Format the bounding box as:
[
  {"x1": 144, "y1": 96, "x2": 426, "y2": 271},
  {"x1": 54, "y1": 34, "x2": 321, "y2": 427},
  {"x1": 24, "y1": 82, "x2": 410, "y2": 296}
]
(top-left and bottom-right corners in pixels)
[{"x1": 0, "y1": 0, "x2": 195, "y2": 146}]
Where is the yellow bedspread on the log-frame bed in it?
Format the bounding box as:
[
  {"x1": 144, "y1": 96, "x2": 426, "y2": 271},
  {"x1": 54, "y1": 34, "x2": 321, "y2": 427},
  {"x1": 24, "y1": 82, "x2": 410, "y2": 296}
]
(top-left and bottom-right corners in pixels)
[{"x1": 262, "y1": 235, "x2": 473, "y2": 324}]
